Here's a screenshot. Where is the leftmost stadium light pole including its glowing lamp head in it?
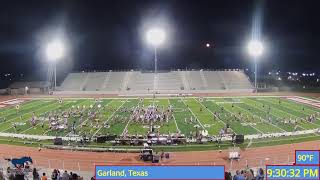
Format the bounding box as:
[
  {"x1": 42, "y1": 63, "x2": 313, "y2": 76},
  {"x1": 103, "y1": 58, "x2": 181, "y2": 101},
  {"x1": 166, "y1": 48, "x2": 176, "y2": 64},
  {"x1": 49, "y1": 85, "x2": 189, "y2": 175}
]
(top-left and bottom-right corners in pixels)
[{"x1": 45, "y1": 40, "x2": 65, "y2": 90}]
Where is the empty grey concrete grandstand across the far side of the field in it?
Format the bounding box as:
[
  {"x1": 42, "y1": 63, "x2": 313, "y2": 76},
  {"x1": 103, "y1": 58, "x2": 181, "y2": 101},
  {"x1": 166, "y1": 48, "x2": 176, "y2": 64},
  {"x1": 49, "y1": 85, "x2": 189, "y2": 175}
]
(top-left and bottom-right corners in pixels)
[{"x1": 59, "y1": 70, "x2": 253, "y2": 94}]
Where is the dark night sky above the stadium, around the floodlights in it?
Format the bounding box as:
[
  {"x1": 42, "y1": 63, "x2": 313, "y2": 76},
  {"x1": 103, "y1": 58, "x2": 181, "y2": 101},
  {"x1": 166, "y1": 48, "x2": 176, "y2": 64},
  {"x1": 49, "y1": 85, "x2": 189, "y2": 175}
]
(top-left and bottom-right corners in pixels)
[{"x1": 0, "y1": 0, "x2": 320, "y2": 81}]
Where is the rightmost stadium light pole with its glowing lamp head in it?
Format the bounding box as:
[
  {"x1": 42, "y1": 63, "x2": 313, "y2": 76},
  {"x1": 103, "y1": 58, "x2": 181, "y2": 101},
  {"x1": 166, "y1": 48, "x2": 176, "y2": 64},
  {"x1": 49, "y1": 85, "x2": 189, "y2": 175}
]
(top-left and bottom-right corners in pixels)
[{"x1": 248, "y1": 40, "x2": 263, "y2": 92}]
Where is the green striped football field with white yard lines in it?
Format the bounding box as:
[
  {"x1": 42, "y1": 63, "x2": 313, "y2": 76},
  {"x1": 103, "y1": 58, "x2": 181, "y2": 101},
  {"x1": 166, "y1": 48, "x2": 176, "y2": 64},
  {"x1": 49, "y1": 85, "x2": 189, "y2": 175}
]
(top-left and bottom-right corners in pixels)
[{"x1": 0, "y1": 97, "x2": 320, "y2": 140}]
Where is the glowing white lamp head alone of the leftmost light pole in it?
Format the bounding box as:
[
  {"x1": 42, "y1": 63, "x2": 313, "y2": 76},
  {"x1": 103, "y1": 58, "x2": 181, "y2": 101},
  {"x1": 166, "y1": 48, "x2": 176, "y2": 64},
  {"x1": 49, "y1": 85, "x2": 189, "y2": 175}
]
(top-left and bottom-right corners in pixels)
[{"x1": 46, "y1": 40, "x2": 64, "y2": 61}]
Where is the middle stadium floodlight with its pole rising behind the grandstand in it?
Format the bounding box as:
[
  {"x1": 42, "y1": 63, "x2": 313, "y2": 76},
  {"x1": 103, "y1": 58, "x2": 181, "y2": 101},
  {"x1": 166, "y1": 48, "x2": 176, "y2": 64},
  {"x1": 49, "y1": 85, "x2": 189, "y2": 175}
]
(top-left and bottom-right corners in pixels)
[{"x1": 146, "y1": 28, "x2": 166, "y2": 74}]
